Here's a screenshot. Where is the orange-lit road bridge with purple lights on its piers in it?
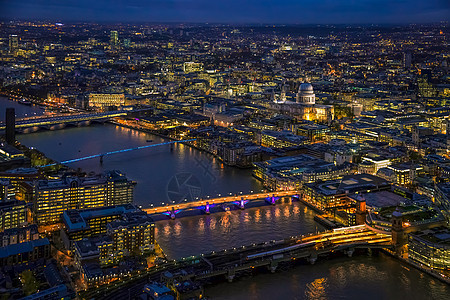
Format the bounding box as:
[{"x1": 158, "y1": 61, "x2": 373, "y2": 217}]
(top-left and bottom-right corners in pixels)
[{"x1": 143, "y1": 191, "x2": 299, "y2": 219}]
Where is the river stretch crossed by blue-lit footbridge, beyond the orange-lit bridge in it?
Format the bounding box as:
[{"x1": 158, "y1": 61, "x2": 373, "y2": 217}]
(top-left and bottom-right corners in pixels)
[{"x1": 17, "y1": 124, "x2": 261, "y2": 207}]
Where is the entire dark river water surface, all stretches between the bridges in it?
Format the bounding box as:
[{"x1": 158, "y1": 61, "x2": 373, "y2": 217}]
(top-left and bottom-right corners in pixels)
[{"x1": 0, "y1": 99, "x2": 450, "y2": 300}]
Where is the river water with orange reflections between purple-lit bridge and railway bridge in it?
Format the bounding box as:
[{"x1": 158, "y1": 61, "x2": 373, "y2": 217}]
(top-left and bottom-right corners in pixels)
[{"x1": 156, "y1": 202, "x2": 323, "y2": 259}]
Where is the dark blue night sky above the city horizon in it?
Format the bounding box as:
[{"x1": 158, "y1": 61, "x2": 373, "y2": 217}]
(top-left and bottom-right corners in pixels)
[{"x1": 0, "y1": 0, "x2": 450, "y2": 24}]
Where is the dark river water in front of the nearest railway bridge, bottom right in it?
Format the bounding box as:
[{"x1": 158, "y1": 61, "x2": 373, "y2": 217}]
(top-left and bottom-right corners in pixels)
[{"x1": 205, "y1": 254, "x2": 450, "y2": 300}]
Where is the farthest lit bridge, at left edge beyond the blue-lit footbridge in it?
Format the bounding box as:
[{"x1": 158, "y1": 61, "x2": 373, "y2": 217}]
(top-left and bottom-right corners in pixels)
[{"x1": 0, "y1": 111, "x2": 127, "y2": 133}]
